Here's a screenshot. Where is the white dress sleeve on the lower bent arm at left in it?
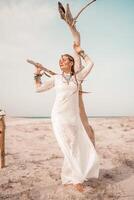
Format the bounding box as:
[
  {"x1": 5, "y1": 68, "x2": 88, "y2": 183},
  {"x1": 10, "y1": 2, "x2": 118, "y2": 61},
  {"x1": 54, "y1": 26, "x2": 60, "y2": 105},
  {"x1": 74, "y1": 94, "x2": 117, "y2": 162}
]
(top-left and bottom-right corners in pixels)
[{"x1": 36, "y1": 75, "x2": 55, "y2": 92}]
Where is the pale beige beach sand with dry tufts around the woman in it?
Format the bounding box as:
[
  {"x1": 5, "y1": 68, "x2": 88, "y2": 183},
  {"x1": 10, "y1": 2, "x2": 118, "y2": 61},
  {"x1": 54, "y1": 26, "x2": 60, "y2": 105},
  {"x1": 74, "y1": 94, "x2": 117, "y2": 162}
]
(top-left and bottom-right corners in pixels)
[{"x1": 0, "y1": 117, "x2": 134, "y2": 200}]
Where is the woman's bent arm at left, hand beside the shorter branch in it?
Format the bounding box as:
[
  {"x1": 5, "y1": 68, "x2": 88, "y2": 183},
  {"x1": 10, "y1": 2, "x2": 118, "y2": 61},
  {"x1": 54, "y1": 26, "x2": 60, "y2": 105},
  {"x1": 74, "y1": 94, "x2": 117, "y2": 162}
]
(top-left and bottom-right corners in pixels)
[{"x1": 34, "y1": 64, "x2": 55, "y2": 92}]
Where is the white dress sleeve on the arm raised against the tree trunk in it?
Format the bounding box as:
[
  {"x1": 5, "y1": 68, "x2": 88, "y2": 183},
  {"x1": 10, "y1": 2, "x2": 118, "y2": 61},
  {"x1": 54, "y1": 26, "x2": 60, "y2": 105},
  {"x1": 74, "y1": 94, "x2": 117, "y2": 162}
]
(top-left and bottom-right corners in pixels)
[{"x1": 76, "y1": 55, "x2": 94, "y2": 81}]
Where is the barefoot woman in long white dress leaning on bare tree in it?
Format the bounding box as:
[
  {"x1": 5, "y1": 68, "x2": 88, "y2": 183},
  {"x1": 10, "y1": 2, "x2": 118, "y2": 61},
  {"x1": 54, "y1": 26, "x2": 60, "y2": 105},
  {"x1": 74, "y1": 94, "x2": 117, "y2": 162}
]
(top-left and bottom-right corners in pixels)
[{"x1": 35, "y1": 44, "x2": 99, "y2": 192}]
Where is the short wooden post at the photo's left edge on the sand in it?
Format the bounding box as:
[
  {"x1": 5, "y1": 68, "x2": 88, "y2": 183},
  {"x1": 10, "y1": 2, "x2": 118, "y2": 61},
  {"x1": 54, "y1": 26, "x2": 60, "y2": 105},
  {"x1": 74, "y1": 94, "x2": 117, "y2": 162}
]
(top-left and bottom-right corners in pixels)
[{"x1": 0, "y1": 110, "x2": 5, "y2": 168}]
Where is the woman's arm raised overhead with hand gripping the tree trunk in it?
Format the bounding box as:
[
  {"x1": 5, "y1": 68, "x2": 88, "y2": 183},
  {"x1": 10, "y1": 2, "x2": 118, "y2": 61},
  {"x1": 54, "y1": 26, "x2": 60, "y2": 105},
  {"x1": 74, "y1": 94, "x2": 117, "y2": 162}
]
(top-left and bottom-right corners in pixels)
[{"x1": 74, "y1": 44, "x2": 94, "y2": 81}]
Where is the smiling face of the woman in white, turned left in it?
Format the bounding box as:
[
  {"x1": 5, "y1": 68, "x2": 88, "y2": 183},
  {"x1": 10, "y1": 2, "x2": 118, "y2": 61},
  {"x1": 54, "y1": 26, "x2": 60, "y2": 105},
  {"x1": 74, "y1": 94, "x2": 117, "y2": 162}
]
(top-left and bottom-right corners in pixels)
[{"x1": 59, "y1": 55, "x2": 73, "y2": 72}]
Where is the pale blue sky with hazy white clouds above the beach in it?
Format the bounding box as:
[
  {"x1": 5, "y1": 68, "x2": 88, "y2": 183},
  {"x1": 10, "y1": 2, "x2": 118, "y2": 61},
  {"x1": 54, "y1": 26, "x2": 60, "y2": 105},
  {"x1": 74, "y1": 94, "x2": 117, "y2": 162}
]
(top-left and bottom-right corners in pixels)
[{"x1": 0, "y1": 0, "x2": 134, "y2": 117}]
